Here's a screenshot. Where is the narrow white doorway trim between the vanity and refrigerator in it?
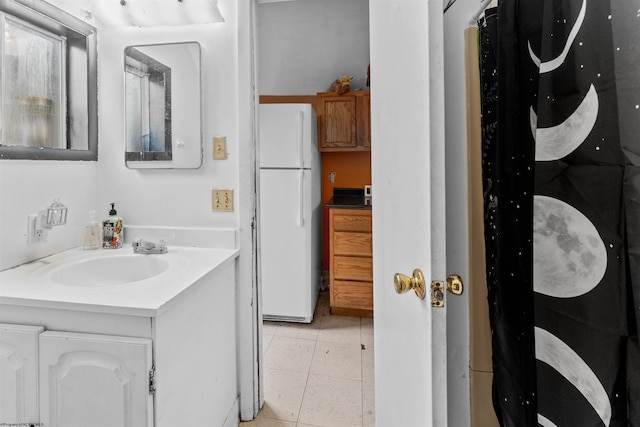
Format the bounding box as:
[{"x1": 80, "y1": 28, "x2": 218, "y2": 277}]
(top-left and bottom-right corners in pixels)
[{"x1": 234, "y1": 0, "x2": 264, "y2": 421}]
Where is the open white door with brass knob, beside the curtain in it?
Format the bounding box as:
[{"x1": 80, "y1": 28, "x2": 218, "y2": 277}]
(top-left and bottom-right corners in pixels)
[{"x1": 369, "y1": 0, "x2": 447, "y2": 427}]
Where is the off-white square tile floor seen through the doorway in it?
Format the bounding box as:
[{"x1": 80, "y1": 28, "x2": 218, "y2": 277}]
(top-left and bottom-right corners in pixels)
[{"x1": 240, "y1": 292, "x2": 375, "y2": 427}]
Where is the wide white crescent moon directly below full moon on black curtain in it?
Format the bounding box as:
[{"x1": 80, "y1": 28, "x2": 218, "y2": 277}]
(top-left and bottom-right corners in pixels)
[{"x1": 534, "y1": 327, "x2": 611, "y2": 426}]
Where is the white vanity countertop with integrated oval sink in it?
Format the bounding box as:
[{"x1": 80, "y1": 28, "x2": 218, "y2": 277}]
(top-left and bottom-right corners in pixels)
[{"x1": 0, "y1": 246, "x2": 239, "y2": 317}]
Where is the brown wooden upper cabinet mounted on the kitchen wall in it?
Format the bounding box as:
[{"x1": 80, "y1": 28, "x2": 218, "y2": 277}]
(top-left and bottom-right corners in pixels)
[{"x1": 316, "y1": 91, "x2": 371, "y2": 152}]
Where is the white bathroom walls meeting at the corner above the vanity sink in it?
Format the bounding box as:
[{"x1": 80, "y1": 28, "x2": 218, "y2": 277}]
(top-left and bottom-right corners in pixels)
[{"x1": 0, "y1": 0, "x2": 240, "y2": 269}]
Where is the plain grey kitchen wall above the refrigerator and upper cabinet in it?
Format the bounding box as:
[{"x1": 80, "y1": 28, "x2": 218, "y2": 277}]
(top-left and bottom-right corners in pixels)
[{"x1": 257, "y1": 0, "x2": 369, "y2": 95}]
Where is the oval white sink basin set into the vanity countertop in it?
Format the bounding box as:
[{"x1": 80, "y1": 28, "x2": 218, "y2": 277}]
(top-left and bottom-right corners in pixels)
[{"x1": 49, "y1": 255, "x2": 171, "y2": 288}]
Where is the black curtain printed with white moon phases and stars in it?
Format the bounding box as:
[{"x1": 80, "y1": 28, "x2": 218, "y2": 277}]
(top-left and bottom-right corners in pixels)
[{"x1": 479, "y1": 0, "x2": 640, "y2": 427}]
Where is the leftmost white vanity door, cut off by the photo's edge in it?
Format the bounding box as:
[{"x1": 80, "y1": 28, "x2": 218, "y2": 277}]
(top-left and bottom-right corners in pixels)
[{"x1": 0, "y1": 324, "x2": 43, "y2": 425}]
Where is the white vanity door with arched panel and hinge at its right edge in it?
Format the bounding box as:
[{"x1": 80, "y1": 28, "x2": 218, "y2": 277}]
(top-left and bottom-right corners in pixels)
[{"x1": 40, "y1": 331, "x2": 153, "y2": 427}]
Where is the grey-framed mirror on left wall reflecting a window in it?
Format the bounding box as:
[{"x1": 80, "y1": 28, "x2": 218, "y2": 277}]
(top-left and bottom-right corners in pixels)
[{"x1": 0, "y1": 0, "x2": 98, "y2": 160}]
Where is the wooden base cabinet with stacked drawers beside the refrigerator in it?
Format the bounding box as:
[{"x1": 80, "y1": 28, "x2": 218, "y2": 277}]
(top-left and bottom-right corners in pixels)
[{"x1": 329, "y1": 209, "x2": 373, "y2": 317}]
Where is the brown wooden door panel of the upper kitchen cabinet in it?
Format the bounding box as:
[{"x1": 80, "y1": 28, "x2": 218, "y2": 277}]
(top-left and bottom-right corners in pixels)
[{"x1": 318, "y1": 95, "x2": 356, "y2": 149}]
